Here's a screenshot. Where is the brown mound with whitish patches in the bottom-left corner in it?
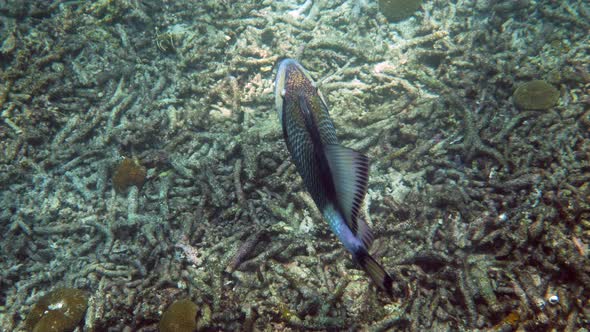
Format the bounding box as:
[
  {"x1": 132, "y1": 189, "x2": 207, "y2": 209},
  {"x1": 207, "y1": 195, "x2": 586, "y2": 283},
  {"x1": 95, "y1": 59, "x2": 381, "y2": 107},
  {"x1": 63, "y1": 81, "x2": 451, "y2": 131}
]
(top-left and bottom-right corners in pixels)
[{"x1": 25, "y1": 288, "x2": 88, "y2": 332}]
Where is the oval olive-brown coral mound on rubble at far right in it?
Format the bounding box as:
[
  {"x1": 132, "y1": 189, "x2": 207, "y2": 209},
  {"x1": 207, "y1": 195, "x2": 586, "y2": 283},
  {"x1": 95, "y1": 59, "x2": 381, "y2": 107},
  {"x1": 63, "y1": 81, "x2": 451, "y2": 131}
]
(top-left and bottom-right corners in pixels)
[{"x1": 513, "y1": 80, "x2": 559, "y2": 110}]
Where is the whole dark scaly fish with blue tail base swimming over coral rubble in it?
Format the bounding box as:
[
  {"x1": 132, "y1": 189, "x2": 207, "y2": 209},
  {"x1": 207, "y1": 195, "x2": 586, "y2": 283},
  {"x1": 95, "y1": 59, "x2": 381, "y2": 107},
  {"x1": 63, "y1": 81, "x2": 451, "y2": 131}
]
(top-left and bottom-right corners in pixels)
[{"x1": 274, "y1": 59, "x2": 392, "y2": 296}]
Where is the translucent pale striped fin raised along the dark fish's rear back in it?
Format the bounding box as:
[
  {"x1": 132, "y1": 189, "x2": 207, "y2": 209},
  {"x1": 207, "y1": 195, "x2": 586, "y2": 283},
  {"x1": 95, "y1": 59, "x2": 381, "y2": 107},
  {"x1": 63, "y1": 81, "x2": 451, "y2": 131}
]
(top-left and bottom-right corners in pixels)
[{"x1": 325, "y1": 144, "x2": 373, "y2": 250}]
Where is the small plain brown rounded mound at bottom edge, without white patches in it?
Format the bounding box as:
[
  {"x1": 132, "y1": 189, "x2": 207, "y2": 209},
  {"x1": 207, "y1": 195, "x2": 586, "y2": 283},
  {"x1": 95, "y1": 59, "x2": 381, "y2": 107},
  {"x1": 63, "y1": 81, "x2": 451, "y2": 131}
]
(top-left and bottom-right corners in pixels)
[{"x1": 158, "y1": 300, "x2": 198, "y2": 332}]
